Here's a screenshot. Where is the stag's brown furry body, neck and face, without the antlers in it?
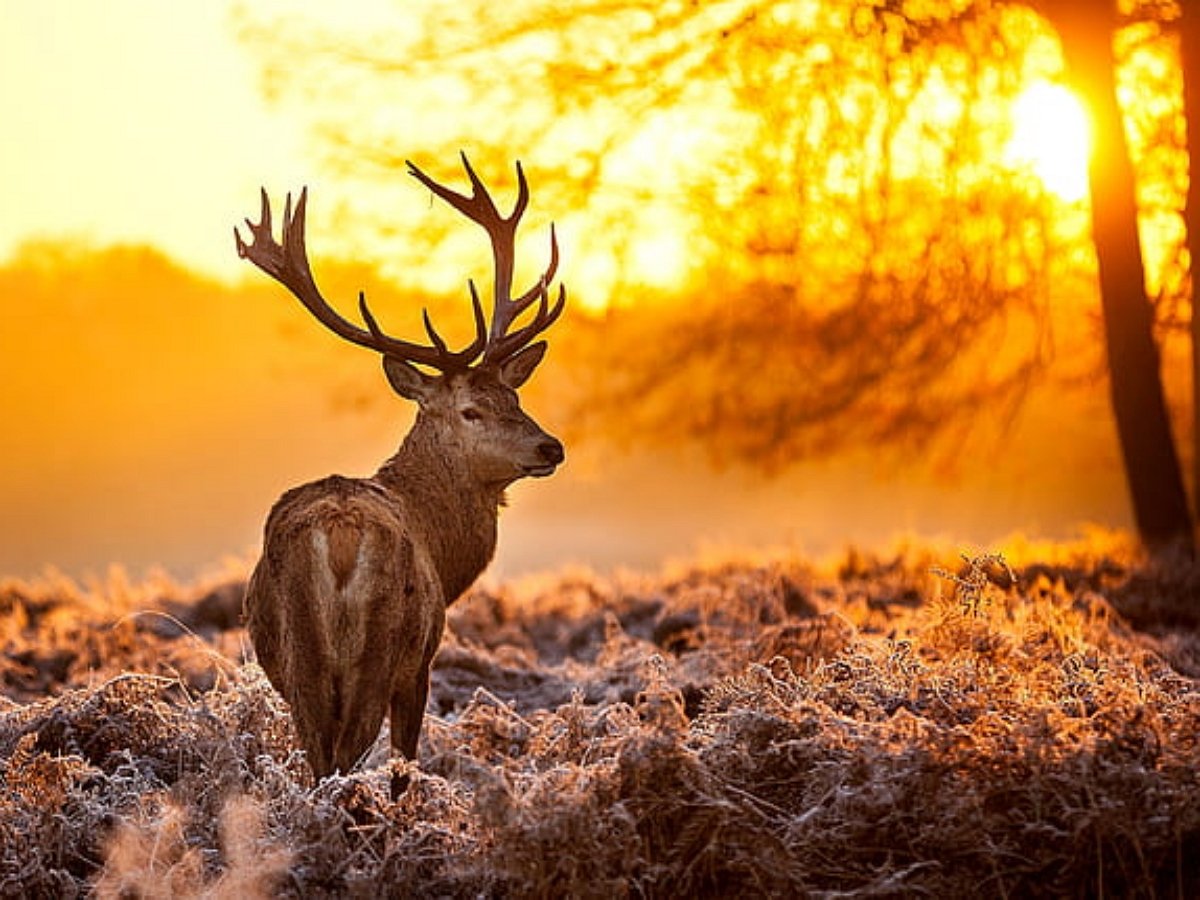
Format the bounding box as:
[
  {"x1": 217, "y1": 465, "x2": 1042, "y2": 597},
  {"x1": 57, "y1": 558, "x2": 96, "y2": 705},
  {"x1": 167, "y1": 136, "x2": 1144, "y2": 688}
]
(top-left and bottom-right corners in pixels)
[{"x1": 245, "y1": 370, "x2": 562, "y2": 778}]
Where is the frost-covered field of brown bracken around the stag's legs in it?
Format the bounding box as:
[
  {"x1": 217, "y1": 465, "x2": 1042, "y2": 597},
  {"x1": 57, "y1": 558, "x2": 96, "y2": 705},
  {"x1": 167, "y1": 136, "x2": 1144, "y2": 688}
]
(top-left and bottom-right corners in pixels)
[{"x1": 0, "y1": 538, "x2": 1200, "y2": 898}]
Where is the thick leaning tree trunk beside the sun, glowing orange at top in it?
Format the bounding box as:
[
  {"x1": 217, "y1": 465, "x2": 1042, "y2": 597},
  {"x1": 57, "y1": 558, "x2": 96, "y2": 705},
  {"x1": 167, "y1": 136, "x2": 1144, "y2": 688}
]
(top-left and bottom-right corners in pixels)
[{"x1": 1045, "y1": 0, "x2": 1193, "y2": 550}]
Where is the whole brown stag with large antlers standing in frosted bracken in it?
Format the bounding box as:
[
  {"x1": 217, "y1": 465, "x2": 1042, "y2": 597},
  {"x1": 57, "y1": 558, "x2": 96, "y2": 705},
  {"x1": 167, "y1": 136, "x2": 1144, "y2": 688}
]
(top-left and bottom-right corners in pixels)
[{"x1": 234, "y1": 154, "x2": 566, "y2": 794}]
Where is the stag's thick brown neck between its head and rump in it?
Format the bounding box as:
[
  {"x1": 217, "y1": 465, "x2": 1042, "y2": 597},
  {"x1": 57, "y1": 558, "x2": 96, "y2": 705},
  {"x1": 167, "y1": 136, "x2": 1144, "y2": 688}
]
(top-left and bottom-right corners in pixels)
[{"x1": 376, "y1": 415, "x2": 504, "y2": 605}]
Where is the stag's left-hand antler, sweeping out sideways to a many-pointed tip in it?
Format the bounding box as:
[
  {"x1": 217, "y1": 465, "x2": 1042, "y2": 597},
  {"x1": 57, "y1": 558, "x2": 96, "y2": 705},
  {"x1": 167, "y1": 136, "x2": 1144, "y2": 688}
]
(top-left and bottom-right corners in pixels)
[{"x1": 233, "y1": 187, "x2": 490, "y2": 372}]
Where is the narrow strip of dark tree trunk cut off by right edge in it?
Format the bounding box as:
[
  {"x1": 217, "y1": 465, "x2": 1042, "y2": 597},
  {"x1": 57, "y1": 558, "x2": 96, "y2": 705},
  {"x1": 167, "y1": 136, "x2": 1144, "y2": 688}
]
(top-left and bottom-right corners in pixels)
[{"x1": 1180, "y1": 4, "x2": 1200, "y2": 525}]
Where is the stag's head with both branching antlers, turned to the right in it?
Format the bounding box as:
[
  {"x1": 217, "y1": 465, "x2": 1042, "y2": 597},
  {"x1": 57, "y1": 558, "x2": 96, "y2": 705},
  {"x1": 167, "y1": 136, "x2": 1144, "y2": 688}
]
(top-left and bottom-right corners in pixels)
[{"x1": 234, "y1": 154, "x2": 566, "y2": 488}]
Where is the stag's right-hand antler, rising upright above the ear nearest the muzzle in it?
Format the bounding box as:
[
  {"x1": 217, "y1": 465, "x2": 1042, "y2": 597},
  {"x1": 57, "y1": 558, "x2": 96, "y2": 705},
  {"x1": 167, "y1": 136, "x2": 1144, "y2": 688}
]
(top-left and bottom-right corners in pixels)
[{"x1": 408, "y1": 154, "x2": 566, "y2": 365}]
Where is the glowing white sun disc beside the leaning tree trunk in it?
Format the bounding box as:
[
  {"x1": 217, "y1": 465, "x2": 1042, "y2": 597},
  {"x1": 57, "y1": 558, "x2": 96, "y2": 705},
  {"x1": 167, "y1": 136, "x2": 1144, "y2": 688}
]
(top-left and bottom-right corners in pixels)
[{"x1": 1004, "y1": 80, "x2": 1092, "y2": 203}]
